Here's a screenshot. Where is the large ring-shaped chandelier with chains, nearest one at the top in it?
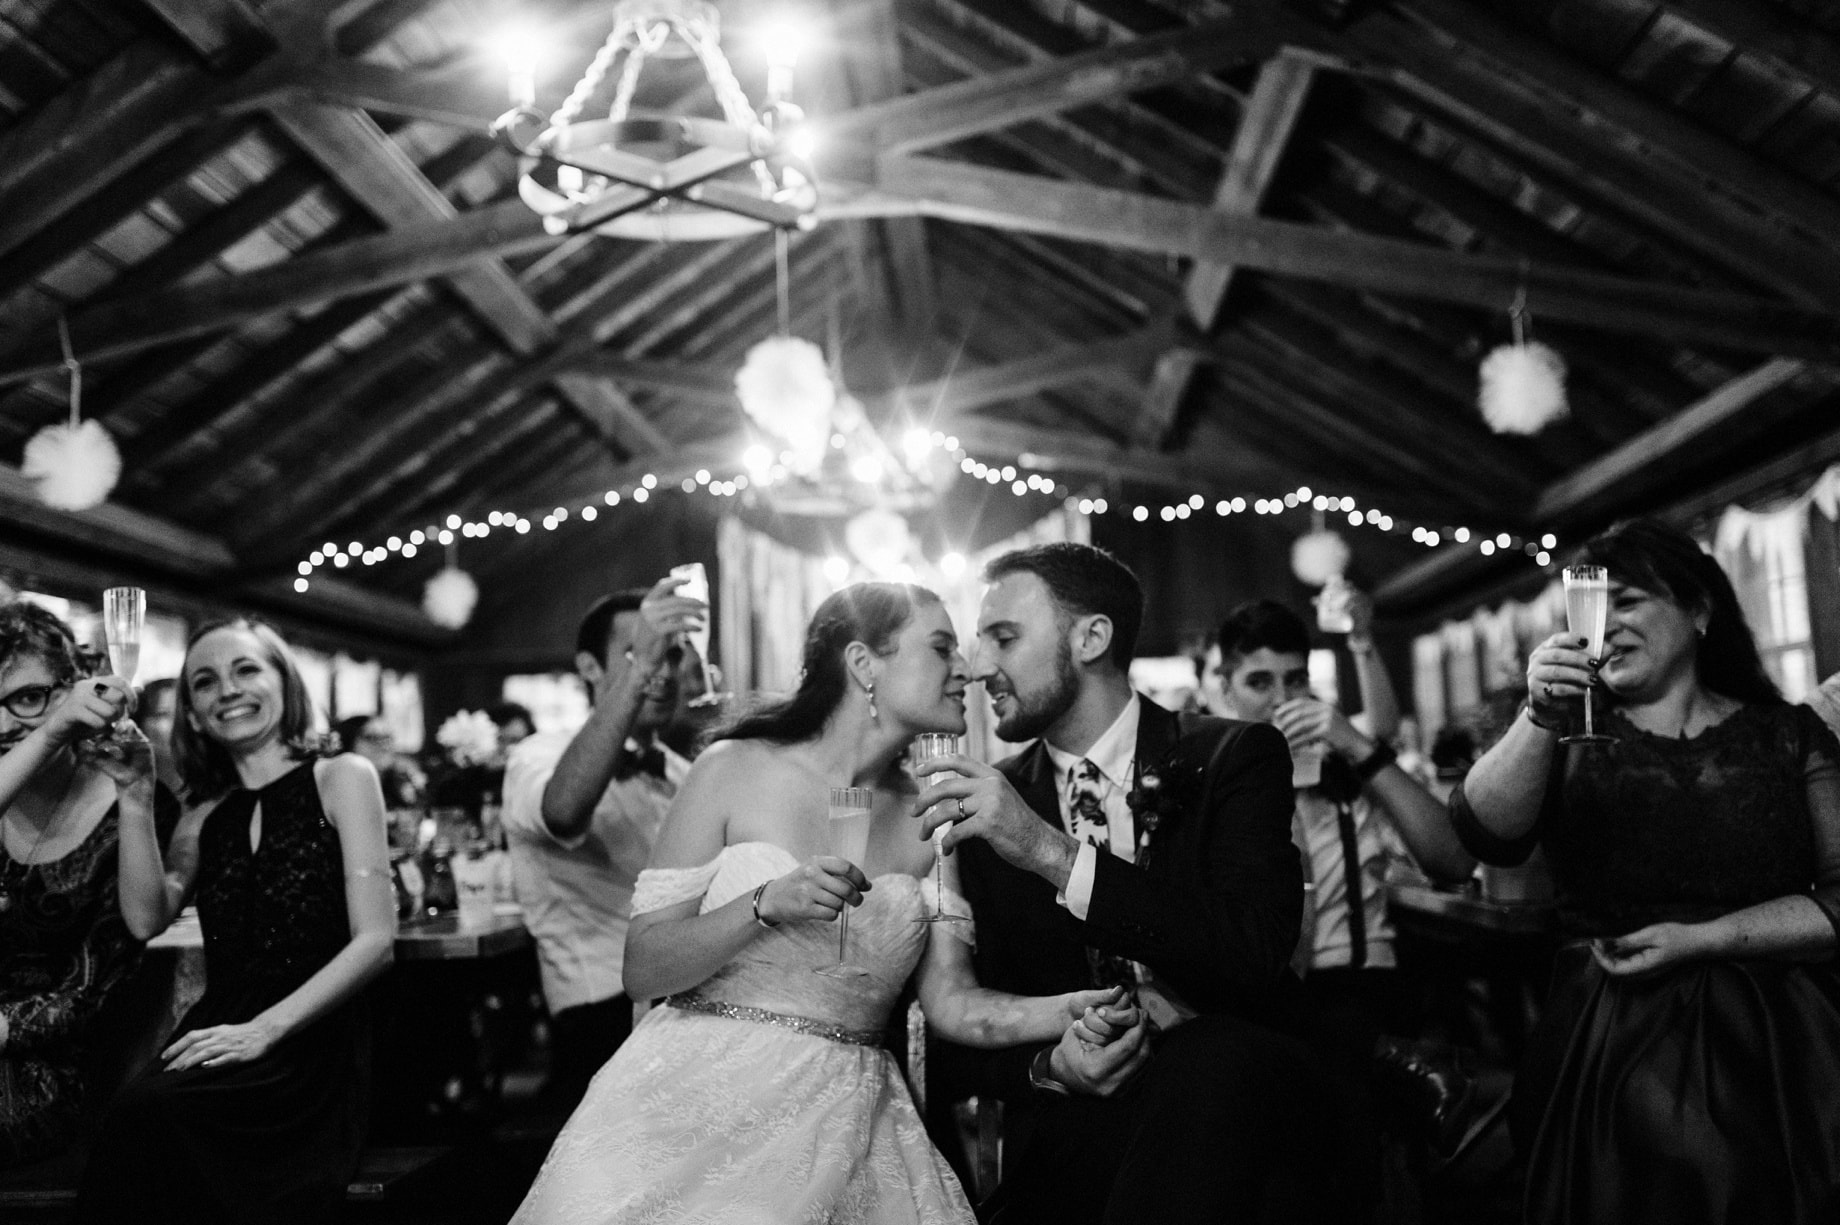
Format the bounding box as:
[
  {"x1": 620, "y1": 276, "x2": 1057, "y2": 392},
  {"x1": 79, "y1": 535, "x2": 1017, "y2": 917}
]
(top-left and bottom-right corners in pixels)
[{"x1": 493, "y1": 0, "x2": 817, "y2": 241}]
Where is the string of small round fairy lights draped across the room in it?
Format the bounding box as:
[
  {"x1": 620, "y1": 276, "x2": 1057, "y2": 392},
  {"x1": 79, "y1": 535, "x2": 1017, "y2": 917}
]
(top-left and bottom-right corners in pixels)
[{"x1": 294, "y1": 430, "x2": 1558, "y2": 592}]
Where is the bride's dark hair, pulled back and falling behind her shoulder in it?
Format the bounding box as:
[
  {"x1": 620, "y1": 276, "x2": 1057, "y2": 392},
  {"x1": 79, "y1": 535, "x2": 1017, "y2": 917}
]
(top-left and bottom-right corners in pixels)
[{"x1": 712, "y1": 583, "x2": 940, "y2": 745}]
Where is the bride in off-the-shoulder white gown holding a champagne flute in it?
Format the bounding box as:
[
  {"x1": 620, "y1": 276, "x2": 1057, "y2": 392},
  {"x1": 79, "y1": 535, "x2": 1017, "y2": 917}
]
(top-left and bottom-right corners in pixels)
[{"x1": 513, "y1": 583, "x2": 1135, "y2": 1225}]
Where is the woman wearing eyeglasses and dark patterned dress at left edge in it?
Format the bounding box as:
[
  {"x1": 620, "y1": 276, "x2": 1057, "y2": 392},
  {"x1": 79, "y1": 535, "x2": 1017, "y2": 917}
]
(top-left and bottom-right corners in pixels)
[{"x1": 0, "y1": 601, "x2": 178, "y2": 1168}]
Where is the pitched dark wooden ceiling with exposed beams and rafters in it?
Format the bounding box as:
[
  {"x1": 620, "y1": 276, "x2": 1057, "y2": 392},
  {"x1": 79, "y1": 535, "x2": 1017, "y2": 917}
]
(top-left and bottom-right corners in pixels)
[{"x1": 0, "y1": 0, "x2": 1840, "y2": 644}]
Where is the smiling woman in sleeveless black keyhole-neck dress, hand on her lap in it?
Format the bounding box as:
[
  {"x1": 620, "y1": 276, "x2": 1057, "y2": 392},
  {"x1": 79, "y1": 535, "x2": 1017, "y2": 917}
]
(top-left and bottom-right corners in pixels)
[{"x1": 75, "y1": 620, "x2": 396, "y2": 1225}]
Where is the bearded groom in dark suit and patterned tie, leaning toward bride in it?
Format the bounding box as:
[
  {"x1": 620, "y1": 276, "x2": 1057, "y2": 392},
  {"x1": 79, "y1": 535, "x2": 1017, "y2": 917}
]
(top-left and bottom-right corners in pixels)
[{"x1": 922, "y1": 544, "x2": 1343, "y2": 1225}]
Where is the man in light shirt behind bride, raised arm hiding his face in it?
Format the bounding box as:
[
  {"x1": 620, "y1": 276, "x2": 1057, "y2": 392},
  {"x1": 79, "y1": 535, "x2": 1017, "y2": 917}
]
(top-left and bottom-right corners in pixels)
[{"x1": 504, "y1": 578, "x2": 708, "y2": 1107}]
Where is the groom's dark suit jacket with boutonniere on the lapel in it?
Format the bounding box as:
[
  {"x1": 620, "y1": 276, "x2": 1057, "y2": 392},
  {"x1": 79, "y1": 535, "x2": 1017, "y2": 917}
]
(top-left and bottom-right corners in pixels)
[{"x1": 949, "y1": 697, "x2": 1303, "y2": 1098}]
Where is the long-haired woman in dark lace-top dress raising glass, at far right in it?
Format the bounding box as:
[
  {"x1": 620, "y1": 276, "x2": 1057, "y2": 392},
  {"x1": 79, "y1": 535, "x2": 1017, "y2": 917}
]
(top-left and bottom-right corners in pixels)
[{"x1": 1452, "y1": 521, "x2": 1840, "y2": 1225}]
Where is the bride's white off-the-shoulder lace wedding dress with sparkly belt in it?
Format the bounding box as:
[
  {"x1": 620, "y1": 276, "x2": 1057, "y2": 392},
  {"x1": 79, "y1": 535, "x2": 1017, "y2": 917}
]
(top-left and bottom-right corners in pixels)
[{"x1": 513, "y1": 842, "x2": 973, "y2": 1225}]
